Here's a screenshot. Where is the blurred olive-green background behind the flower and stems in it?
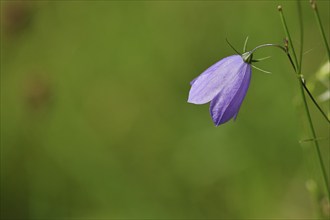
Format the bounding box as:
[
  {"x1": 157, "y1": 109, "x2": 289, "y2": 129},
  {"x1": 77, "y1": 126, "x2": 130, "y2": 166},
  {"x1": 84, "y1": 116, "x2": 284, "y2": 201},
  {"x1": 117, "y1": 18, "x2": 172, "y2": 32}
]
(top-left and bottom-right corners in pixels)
[{"x1": 1, "y1": 1, "x2": 329, "y2": 219}]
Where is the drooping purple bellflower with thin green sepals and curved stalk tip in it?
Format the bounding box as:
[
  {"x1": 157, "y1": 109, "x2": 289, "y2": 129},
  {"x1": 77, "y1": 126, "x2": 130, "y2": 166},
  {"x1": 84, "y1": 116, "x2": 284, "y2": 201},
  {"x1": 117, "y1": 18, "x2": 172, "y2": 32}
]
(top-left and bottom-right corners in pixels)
[{"x1": 188, "y1": 39, "x2": 283, "y2": 126}]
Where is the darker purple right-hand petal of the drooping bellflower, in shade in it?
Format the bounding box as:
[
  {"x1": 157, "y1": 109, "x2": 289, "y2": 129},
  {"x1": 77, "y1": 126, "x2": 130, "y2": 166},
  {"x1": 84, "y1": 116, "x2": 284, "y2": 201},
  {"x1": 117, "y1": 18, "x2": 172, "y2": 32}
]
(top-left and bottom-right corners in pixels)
[{"x1": 210, "y1": 64, "x2": 251, "y2": 126}]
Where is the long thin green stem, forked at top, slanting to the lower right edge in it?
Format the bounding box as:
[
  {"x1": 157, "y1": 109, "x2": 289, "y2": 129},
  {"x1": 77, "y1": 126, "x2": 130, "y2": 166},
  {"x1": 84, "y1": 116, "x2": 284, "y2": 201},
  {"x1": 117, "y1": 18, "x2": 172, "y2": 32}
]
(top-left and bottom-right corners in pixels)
[{"x1": 278, "y1": 3, "x2": 330, "y2": 199}]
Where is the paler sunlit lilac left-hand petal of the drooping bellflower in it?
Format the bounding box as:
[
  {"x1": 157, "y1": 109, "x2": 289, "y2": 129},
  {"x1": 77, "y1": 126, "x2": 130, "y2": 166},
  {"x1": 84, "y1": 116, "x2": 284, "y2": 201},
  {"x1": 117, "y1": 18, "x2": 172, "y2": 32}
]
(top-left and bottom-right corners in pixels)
[{"x1": 188, "y1": 55, "x2": 246, "y2": 104}]
